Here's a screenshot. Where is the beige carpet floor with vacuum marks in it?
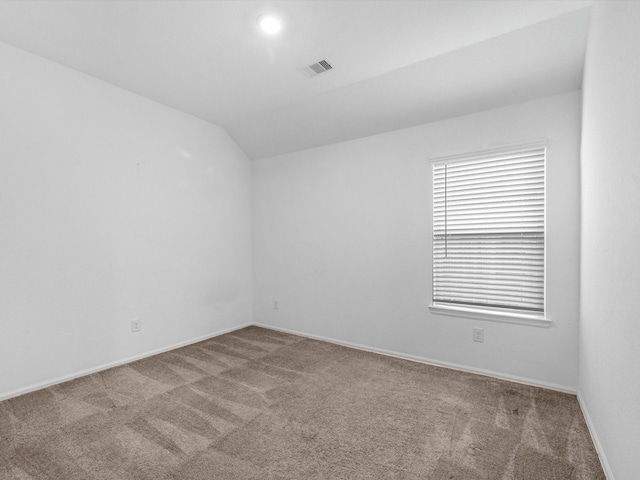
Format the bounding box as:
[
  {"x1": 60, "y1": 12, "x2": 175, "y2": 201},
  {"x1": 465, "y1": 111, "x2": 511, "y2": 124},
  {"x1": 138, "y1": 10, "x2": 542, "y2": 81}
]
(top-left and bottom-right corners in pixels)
[{"x1": 0, "y1": 327, "x2": 605, "y2": 480}]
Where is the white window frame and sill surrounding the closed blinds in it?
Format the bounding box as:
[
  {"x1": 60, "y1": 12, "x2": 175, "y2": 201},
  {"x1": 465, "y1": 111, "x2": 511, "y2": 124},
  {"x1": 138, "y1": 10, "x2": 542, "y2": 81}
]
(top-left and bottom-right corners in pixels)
[{"x1": 429, "y1": 139, "x2": 552, "y2": 327}]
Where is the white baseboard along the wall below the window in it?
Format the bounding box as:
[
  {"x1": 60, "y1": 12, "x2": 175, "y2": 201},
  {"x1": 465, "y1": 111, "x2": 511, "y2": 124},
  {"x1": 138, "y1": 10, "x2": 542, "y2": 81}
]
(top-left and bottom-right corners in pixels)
[{"x1": 253, "y1": 323, "x2": 576, "y2": 395}]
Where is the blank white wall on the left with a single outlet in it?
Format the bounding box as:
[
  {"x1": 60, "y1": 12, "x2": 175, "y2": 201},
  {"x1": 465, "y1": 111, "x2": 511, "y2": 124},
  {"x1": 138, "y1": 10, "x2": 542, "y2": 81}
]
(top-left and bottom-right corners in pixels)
[{"x1": 0, "y1": 44, "x2": 252, "y2": 397}]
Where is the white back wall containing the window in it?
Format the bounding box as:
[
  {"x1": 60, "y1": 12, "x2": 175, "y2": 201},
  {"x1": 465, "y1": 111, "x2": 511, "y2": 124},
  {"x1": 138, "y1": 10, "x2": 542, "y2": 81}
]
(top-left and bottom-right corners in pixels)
[{"x1": 253, "y1": 92, "x2": 580, "y2": 390}]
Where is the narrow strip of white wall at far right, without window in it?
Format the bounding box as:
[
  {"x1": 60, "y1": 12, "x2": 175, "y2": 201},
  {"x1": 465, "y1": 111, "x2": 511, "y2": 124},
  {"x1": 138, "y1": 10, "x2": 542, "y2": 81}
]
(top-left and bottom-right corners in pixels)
[{"x1": 579, "y1": 1, "x2": 640, "y2": 480}]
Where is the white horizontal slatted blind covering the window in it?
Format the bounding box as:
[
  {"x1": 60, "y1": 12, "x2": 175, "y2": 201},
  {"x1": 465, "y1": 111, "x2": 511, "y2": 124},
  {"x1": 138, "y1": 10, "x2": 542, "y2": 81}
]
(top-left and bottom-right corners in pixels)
[{"x1": 433, "y1": 146, "x2": 546, "y2": 313}]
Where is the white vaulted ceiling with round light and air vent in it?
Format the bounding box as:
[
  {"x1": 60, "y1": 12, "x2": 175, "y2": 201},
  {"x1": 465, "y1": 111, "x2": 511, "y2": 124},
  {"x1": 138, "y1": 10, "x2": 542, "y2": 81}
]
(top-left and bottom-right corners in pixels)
[{"x1": 0, "y1": 0, "x2": 592, "y2": 159}]
